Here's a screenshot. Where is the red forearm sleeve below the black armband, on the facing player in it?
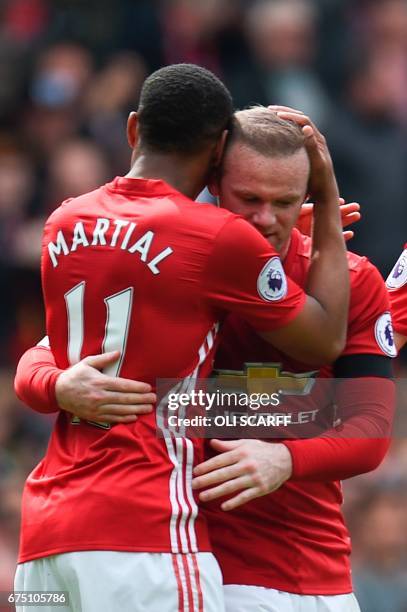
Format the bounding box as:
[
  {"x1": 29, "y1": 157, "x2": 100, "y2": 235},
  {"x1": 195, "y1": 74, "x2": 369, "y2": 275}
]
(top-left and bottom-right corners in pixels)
[{"x1": 283, "y1": 378, "x2": 395, "y2": 481}]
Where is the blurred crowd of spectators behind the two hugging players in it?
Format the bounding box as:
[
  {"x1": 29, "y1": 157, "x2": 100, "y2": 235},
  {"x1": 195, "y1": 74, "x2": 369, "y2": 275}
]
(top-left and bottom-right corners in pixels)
[{"x1": 0, "y1": 0, "x2": 407, "y2": 612}]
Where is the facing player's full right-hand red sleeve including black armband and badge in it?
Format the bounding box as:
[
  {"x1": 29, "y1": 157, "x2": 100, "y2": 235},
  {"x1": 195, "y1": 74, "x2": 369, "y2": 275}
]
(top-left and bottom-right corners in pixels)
[{"x1": 284, "y1": 259, "x2": 396, "y2": 481}]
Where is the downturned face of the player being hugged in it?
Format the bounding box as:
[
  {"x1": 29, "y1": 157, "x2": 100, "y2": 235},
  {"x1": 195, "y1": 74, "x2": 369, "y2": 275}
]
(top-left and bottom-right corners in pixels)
[{"x1": 212, "y1": 143, "x2": 310, "y2": 256}]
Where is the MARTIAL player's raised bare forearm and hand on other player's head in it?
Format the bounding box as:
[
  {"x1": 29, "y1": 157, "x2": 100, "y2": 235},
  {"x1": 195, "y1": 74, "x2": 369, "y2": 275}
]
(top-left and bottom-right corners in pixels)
[{"x1": 270, "y1": 106, "x2": 349, "y2": 364}]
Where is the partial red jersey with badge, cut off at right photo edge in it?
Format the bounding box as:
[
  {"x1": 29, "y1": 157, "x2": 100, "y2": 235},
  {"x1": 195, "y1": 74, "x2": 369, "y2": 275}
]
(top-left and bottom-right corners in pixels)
[{"x1": 386, "y1": 244, "x2": 407, "y2": 338}]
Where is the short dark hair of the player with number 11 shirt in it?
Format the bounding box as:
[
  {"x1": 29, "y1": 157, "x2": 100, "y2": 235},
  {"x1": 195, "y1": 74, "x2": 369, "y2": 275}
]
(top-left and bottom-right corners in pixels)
[{"x1": 139, "y1": 64, "x2": 233, "y2": 154}]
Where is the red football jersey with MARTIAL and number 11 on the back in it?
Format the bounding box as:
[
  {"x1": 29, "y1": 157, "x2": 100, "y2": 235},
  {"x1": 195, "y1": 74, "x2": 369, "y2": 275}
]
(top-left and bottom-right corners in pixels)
[{"x1": 19, "y1": 178, "x2": 305, "y2": 562}]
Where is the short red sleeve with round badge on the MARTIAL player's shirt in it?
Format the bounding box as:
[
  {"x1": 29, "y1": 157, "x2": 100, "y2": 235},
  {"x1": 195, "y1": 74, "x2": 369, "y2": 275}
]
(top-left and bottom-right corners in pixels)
[{"x1": 203, "y1": 218, "x2": 306, "y2": 331}]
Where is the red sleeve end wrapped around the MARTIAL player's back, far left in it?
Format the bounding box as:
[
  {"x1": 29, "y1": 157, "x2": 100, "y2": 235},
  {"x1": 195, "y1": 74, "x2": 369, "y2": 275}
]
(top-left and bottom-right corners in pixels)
[{"x1": 14, "y1": 346, "x2": 62, "y2": 413}]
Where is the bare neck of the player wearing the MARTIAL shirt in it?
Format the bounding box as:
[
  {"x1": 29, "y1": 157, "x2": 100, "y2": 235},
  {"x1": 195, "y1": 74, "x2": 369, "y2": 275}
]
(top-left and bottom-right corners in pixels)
[{"x1": 126, "y1": 154, "x2": 207, "y2": 200}]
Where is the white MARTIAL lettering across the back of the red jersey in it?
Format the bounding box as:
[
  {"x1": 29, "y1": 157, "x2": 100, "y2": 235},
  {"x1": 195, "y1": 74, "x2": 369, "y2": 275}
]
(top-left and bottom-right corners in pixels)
[{"x1": 47, "y1": 217, "x2": 174, "y2": 274}]
